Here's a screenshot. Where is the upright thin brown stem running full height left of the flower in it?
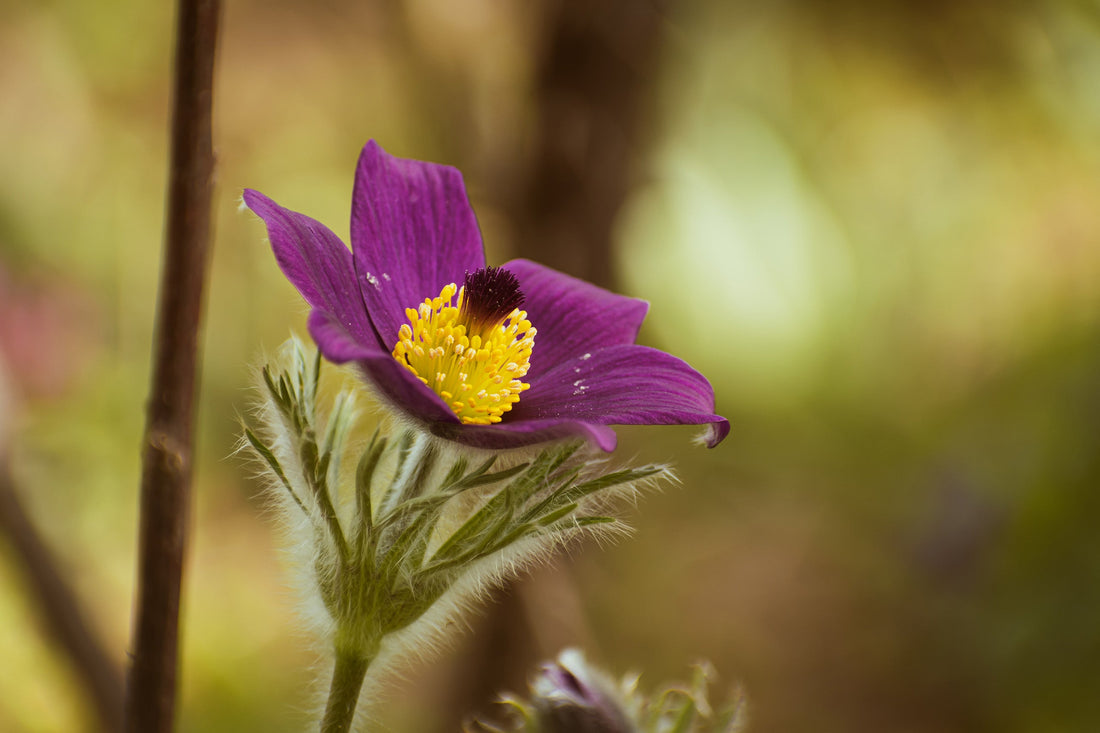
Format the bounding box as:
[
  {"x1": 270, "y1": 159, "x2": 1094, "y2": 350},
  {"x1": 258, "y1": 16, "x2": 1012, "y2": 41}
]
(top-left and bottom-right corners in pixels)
[{"x1": 125, "y1": 0, "x2": 220, "y2": 733}]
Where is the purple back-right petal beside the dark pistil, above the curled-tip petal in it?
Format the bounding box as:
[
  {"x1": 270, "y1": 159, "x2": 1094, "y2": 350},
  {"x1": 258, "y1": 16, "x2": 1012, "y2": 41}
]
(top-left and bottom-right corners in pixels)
[{"x1": 503, "y1": 260, "x2": 649, "y2": 378}]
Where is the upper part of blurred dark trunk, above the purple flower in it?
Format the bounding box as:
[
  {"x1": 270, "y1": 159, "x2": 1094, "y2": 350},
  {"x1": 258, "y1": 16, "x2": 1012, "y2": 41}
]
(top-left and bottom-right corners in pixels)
[{"x1": 506, "y1": 0, "x2": 671, "y2": 289}]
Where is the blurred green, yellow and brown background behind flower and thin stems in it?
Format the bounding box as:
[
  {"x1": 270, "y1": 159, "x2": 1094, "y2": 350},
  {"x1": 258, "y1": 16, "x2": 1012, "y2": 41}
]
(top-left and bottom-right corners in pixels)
[{"x1": 0, "y1": 0, "x2": 1100, "y2": 733}]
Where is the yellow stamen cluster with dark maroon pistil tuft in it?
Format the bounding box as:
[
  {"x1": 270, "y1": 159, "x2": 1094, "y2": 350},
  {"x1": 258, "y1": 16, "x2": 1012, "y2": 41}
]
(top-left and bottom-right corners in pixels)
[{"x1": 394, "y1": 267, "x2": 536, "y2": 425}]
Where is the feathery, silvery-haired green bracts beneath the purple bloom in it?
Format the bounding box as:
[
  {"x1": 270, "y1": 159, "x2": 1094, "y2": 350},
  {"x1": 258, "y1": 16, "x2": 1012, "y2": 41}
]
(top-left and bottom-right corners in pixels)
[{"x1": 245, "y1": 340, "x2": 668, "y2": 686}]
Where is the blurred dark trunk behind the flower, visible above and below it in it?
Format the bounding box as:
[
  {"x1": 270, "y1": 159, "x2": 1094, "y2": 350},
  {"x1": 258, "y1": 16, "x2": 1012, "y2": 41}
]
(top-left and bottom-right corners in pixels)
[{"x1": 442, "y1": 0, "x2": 669, "y2": 730}]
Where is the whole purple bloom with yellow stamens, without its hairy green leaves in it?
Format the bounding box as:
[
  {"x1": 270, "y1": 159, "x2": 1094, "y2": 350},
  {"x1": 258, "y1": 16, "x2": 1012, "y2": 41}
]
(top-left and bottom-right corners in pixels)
[{"x1": 244, "y1": 141, "x2": 729, "y2": 451}]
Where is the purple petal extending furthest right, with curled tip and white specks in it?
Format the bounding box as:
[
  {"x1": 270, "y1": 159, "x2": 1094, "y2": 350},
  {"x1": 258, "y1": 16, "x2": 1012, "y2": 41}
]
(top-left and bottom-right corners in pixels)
[{"x1": 506, "y1": 342, "x2": 729, "y2": 448}]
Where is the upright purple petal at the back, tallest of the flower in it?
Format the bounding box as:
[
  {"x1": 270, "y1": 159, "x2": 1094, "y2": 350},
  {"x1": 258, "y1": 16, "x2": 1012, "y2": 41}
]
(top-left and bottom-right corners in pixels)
[{"x1": 351, "y1": 140, "x2": 485, "y2": 347}]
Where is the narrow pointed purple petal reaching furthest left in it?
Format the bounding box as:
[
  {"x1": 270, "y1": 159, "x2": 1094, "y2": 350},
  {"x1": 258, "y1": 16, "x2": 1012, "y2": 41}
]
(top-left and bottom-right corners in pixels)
[{"x1": 244, "y1": 189, "x2": 378, "y2": 349}]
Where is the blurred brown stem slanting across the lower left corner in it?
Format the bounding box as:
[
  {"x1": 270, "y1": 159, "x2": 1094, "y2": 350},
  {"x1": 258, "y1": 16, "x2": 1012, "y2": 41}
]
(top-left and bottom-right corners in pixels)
[{"x1": 0, "y1": 457, "x2": 122, "y2": 731}]
